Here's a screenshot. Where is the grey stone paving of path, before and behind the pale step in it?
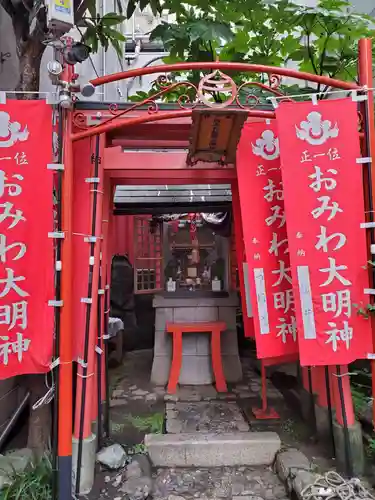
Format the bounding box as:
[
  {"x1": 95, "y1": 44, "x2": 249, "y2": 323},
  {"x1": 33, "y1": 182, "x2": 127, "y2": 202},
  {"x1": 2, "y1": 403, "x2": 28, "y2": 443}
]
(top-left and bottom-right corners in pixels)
[{"x1": 90, "y1": 351, "x2": 288, "y2": 500}]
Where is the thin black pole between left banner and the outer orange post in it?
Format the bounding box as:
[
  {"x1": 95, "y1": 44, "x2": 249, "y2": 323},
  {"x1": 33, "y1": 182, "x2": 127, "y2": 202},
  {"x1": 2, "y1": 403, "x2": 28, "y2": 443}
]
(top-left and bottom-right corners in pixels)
[{"x1": 52, "y1": 107, "x2": 64, "y2": 500}]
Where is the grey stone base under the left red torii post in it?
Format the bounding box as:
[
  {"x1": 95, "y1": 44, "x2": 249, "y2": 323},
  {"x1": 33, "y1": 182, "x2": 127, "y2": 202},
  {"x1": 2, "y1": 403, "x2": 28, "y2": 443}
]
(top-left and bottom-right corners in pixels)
[{"x1": 72, "y1": 434, "x2": 96, "y2": 495}]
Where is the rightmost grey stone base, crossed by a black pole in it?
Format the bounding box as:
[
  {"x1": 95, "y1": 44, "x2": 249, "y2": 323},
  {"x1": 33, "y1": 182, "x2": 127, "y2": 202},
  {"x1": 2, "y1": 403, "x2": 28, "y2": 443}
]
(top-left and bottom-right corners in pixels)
[{"x1": 333, "y1": 420, "x2": 365, "y2": 476}]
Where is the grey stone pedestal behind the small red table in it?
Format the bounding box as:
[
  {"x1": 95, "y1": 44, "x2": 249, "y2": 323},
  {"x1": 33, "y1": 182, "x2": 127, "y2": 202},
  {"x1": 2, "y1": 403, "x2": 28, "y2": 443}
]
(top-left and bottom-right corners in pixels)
[{"x1": 151, "y1": 293, "x2": 242, "y2": 385}]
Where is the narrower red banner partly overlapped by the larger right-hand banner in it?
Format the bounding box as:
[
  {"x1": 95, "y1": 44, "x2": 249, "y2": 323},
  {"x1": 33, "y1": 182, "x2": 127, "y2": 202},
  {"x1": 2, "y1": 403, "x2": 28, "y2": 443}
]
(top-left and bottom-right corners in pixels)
[{"x1": 237, "y1": 122, "x2": 298, "y2": 358}]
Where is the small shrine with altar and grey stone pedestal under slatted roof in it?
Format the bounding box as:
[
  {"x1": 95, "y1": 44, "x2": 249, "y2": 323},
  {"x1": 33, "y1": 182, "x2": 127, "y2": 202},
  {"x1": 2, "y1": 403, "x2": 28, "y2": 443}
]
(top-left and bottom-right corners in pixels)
[{"x1": 110, "y1": 185, "x2": 241, "y2": 386}]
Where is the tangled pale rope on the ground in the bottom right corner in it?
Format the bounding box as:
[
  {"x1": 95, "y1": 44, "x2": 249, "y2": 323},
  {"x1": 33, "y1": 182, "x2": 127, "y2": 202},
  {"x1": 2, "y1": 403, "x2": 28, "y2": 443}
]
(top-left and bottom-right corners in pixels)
[{"x1": 301, "y1": 471, "x2": 375, "y2": 500}]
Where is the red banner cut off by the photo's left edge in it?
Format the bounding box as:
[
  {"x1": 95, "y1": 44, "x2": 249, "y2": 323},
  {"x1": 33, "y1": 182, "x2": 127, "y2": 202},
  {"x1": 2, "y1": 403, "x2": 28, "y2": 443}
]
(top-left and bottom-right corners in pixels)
[{"x1": 0, "y1": 100, "x2": 54, "y2": 379}]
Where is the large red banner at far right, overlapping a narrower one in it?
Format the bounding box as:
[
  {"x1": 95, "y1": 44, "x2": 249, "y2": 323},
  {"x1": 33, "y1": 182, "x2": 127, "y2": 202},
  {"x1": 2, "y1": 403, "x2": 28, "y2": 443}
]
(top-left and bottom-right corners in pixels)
[{"x1": 276, "y1": 99, "x2": 372, "y2": 365}]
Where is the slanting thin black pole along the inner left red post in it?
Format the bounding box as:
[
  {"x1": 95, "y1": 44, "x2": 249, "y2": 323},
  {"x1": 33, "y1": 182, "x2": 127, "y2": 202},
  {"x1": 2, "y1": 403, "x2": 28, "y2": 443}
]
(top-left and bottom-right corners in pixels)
[{"x1": 75, "y1": 136, "x2": 100, "y2": 496}]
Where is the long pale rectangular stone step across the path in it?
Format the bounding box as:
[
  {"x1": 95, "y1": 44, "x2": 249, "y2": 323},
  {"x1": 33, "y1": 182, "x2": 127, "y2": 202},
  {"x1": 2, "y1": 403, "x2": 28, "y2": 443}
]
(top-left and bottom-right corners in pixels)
[{"x1": 145, "y1": 432, "x2": 281, "y2": 467}]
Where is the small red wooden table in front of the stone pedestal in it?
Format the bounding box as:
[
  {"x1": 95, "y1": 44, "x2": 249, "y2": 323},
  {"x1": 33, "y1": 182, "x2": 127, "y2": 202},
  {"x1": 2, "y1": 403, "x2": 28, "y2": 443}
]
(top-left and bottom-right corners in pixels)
[{"x1": 166, "y1": 321, "x2": 228, "y2": 394}]
